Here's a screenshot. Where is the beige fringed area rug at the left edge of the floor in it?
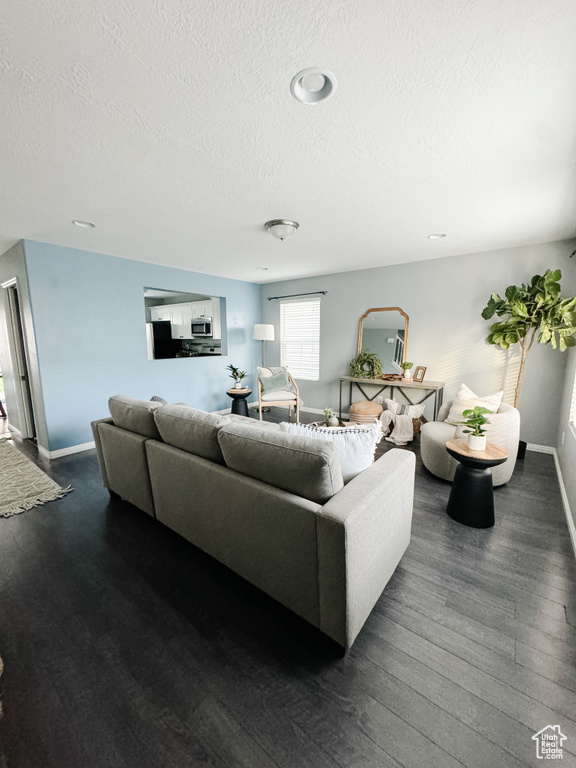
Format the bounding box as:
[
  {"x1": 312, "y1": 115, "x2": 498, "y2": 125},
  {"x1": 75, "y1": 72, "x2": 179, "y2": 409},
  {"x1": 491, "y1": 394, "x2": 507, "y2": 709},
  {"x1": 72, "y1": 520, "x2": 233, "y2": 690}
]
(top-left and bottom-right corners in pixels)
[{"x1": 0, "y1": 440, "x2": 72, "y2": 517}]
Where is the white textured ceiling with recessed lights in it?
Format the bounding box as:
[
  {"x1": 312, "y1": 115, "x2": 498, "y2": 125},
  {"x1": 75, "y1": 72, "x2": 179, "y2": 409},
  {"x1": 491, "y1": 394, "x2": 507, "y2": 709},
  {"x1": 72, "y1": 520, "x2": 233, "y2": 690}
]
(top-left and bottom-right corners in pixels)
[{"x1": 0, "y1": 0, "x2": 576, "y2": 282}]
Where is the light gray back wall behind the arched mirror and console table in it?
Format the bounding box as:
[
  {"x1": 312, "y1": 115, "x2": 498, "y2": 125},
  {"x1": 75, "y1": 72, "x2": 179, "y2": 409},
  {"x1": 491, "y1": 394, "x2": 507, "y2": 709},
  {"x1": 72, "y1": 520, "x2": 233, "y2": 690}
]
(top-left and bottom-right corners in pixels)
[{"x1": 262, "y1": 241, "x2": 576, "y2": 446}]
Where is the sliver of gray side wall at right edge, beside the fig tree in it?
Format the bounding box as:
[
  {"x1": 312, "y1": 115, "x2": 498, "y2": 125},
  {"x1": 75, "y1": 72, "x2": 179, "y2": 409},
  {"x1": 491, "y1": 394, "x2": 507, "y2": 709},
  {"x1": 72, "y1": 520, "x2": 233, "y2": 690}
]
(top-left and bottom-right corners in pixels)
[{"x1": 557, "y1": 240, "x2": 576, "y2": 544}]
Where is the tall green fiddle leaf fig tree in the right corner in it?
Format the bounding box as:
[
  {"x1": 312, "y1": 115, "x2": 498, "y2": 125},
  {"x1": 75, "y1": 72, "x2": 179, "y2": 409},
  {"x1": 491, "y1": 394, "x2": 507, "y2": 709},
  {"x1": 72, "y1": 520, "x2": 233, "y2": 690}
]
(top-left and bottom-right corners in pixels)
[{"x1": 482, "y1": 269, "x2": 576, "y2": 408}]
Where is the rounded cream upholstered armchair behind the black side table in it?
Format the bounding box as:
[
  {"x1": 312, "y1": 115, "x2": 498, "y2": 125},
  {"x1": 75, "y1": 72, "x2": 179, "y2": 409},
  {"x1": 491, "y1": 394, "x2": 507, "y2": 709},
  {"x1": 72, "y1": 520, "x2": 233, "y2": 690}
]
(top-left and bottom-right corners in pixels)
[{"x1": 420, "y1": 401, "x2": 520, "y2": 486}]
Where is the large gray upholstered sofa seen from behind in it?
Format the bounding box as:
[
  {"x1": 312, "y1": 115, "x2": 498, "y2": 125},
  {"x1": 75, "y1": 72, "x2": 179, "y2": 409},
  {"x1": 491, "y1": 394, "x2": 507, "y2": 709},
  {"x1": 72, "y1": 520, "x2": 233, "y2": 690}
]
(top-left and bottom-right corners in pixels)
[{"x1": 92, "y1": 395, "x2": 415, "y2": 648}]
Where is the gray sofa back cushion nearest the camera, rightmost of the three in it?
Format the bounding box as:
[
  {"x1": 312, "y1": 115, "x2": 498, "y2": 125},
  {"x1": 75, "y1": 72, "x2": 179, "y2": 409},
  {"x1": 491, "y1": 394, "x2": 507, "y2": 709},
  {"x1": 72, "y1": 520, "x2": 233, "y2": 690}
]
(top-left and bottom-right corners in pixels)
[{"x1": 218, "y1": 424, "x2": 344, "y2": 504}]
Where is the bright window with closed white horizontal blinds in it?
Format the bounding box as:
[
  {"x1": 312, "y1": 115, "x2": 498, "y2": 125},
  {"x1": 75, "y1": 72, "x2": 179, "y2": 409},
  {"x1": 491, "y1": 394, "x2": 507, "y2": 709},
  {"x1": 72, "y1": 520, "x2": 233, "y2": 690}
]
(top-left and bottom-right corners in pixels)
[{"x1": 280, "y1": 299, "x2": 320, "y2": 381}]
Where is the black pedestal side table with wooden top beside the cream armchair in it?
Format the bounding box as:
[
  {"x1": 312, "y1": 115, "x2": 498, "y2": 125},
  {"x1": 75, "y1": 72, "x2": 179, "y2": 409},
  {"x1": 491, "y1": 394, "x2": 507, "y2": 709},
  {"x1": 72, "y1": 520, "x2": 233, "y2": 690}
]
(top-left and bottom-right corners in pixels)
[{"x1": 446, "y1": 438, "x2": 508, "y2": 528}]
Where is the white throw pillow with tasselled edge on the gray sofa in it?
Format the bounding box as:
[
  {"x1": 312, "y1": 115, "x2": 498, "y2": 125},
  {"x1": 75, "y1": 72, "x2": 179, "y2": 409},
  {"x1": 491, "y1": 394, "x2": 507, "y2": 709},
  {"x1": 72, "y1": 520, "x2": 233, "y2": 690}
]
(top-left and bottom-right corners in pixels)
[{"x1": 280, "y1": 421, "x2": 382, "y2": 483}]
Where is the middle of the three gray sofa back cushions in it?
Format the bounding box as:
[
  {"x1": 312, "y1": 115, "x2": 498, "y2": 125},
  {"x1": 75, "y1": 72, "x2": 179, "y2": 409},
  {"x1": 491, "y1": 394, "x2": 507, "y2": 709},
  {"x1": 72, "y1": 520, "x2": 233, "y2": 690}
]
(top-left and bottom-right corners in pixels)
[{"x1": 155, "y1": 405, "x2": 232, "y2": 464}]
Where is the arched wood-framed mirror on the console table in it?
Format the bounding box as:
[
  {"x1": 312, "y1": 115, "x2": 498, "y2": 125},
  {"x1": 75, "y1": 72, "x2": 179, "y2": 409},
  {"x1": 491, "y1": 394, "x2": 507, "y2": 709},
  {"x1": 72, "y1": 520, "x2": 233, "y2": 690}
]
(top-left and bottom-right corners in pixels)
[{"x1": 358, "y1": 307, "x2": 410, "y2": 374}]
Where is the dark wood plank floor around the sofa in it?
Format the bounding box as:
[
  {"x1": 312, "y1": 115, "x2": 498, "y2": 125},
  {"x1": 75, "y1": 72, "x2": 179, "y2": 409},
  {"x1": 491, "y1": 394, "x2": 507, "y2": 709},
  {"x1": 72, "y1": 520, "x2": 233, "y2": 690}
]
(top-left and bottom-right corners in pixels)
[{"x1": 0, "y1": 414, "x2": 576, "y2": 768}]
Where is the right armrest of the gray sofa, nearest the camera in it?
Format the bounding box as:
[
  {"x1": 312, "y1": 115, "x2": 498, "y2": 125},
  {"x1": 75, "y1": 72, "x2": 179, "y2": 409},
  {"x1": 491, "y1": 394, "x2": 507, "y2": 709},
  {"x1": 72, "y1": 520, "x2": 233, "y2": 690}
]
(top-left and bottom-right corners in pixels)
[{"x1": 316, "y1": 449, "x2": 416, "y2": 648}]
